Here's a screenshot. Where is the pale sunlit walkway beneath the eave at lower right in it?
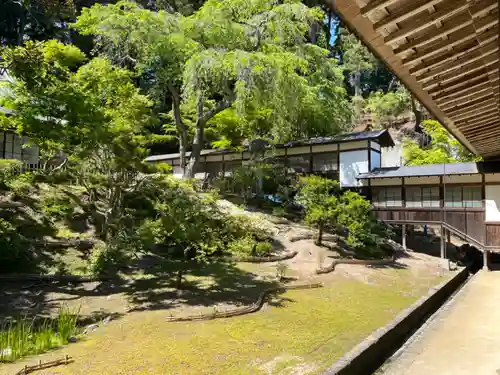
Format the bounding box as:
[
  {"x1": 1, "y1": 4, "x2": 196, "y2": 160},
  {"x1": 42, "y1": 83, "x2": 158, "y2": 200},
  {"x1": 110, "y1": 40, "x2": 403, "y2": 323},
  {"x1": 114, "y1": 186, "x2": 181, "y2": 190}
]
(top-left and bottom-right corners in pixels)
[{"x1": 377, "y1": 271, "x2": 500, "y2": 375}]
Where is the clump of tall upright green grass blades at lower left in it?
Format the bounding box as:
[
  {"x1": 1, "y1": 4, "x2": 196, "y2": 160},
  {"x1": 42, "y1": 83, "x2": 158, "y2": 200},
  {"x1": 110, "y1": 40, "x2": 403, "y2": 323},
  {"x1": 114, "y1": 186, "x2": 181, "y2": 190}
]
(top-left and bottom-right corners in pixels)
[{"x1": 0, "y1": 305, "x2": 78, "y2": 362}]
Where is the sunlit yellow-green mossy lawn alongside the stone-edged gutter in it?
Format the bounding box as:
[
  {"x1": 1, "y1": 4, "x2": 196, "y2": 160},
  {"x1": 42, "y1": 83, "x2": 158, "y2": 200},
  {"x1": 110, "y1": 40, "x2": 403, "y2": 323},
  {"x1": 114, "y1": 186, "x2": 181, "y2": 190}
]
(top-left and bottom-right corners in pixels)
[{"x1": 9, "y1": 269, "x2": 443, "y2": 375}]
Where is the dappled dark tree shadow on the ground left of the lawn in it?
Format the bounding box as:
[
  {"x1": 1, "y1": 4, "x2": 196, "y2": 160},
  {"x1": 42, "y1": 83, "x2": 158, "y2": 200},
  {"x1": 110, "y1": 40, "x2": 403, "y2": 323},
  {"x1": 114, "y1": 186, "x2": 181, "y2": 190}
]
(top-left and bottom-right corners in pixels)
[{"x1": 0, "y1": 262, "x2": 291, "y2": 321}]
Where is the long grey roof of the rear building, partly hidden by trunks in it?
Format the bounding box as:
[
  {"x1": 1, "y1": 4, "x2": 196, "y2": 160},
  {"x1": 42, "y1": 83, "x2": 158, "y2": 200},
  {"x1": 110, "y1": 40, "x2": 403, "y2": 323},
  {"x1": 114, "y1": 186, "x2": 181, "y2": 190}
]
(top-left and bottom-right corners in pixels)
[{"x1": 144, "y1": 129, "x2": 394, "y2": 162}]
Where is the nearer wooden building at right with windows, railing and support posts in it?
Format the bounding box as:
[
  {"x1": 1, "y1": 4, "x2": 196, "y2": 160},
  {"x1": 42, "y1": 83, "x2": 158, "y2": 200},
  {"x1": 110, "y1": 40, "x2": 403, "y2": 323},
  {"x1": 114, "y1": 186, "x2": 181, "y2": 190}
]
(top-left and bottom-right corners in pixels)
[{"x1": 358, "y1": 162, "x2": 500, "y2": 265}]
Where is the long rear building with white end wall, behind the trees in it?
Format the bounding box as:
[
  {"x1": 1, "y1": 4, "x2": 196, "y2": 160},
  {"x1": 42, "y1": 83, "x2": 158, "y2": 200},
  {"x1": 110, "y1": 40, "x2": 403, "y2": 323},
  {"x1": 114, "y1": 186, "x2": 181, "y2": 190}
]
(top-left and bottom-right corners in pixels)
[{"x1": 145, "y1": 130, "x2": 394, "y2": 187}]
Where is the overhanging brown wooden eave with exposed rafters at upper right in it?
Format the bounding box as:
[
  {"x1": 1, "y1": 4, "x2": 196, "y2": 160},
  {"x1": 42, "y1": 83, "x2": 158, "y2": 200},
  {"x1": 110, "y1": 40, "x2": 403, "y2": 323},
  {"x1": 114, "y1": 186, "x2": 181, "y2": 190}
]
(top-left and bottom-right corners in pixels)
[{"x1": 331, "y1": 0, "x2": 500, "y2": 158}]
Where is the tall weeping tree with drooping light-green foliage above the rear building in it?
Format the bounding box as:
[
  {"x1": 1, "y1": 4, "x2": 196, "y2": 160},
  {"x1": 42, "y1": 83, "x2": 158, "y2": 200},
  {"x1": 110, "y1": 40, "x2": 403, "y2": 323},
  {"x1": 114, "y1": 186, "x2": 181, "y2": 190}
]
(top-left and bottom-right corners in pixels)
[{"x1": 76, "y1": 0, "x2": 351, "y2": 176}]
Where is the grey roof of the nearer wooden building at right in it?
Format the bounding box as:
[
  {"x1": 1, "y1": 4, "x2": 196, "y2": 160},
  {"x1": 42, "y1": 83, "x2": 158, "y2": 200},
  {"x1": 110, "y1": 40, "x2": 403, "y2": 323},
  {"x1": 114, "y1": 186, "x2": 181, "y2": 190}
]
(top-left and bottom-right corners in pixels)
[{"x1": 357, "y1": 162, "x2": 500, "y2": 179}]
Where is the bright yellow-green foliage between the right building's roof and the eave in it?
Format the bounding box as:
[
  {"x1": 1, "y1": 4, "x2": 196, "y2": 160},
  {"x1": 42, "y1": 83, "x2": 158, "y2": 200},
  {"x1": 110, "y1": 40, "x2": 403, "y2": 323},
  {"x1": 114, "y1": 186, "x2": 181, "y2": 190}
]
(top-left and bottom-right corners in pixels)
[{"x1": 403, "y1": 120, "x2": 480, "y2": 165}]
